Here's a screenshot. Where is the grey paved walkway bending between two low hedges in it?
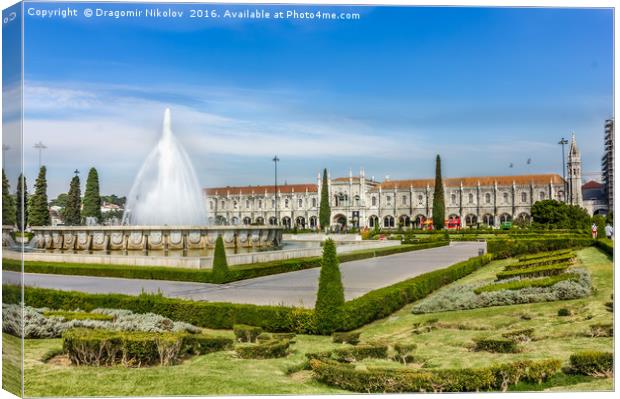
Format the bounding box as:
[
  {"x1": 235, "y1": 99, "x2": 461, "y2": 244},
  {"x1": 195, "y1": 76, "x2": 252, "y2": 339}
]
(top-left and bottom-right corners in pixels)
[{"x1": 2, "y1": 242, "x2": 486, "y2": 307}]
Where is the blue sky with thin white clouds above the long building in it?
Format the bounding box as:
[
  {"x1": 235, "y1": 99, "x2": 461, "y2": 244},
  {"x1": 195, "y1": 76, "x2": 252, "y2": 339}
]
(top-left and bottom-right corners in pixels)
[{"x1": 12, "y1": 3, "x2": 613, "y2": 196}]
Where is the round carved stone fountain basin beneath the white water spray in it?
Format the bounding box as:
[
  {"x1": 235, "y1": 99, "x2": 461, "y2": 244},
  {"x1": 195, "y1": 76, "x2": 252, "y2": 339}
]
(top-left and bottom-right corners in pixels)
[{"x1": 32, "y1": 226, "x2": 282, "y2": 251}]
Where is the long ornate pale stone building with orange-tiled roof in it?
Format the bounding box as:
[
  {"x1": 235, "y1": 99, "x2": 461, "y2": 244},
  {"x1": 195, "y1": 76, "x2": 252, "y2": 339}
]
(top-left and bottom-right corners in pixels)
[{"x1": 204, "y1": 169, "x2": 566, "y2": 228}]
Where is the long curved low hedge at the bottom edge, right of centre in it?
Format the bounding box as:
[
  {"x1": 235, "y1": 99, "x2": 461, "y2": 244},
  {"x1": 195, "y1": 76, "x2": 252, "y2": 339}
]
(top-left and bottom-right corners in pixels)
[{"x1": 310, "y1": 359, "x2": 561, "y2": 393}]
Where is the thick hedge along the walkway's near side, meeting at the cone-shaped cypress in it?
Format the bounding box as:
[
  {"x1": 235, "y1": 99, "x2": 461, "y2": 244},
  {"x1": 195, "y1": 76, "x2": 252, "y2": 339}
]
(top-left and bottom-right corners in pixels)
[{"x1": 2, "y1": 255, "x2": 492, "y2": 334}]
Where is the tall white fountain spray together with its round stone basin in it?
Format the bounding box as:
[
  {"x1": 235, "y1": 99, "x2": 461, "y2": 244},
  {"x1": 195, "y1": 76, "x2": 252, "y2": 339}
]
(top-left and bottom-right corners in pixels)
[{"x1": 27, "y1": 109, "x2": 282, "y2": 264}]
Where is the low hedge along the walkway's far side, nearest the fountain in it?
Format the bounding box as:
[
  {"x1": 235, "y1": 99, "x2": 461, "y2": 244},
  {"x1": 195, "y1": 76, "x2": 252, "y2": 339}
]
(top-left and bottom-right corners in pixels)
[{"x1": 2, "y1": 241, "x2": 449, "y2": 284}]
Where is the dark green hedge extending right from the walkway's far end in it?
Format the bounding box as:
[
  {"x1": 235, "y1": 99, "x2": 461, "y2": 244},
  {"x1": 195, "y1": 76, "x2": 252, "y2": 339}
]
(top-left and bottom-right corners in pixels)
[{"x1": 487, "y1": 236, "x2": 596, "y2": 259}]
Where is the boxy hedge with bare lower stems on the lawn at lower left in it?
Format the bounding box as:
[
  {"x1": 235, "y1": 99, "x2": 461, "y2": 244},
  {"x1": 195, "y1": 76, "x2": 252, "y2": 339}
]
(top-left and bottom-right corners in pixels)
[{"x1": 63, "y1": 328, "x2": 232, "y2": 367}]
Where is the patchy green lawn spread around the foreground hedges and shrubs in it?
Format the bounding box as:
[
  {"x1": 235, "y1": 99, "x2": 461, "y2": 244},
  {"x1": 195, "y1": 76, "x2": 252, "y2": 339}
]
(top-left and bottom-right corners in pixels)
[{"x1": 15, "y1": 248, "x2": 613, "y2": 396}]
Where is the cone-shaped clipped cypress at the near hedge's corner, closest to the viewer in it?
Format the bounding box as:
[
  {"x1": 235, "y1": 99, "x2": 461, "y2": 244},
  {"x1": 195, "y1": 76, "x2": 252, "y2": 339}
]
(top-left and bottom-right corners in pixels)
[{"x1": 314, "y1": 239, "x2": 344, "y2": 334}]
